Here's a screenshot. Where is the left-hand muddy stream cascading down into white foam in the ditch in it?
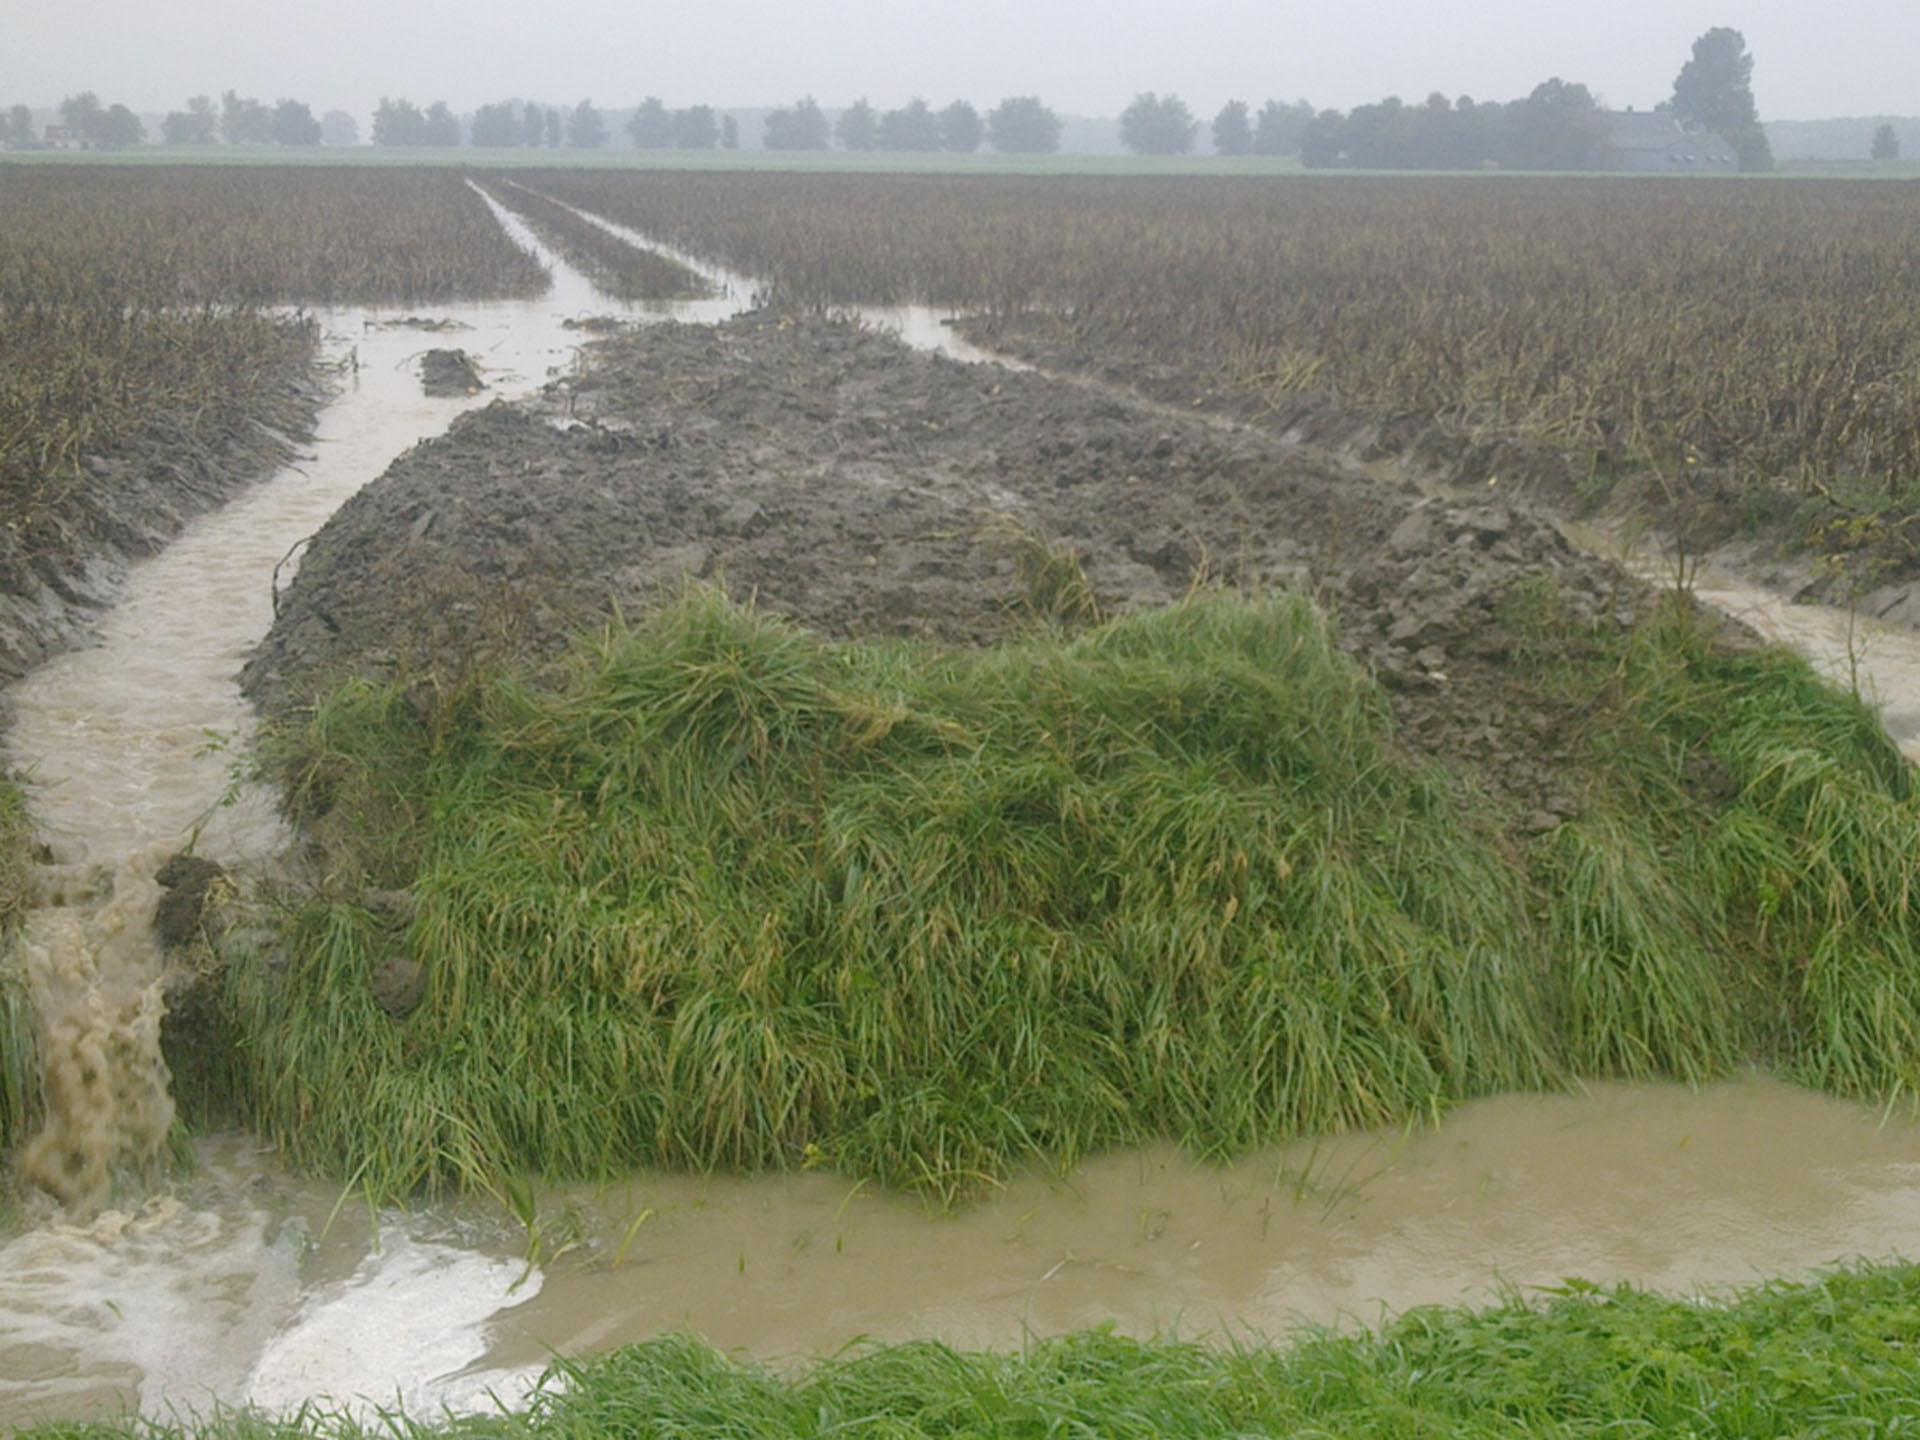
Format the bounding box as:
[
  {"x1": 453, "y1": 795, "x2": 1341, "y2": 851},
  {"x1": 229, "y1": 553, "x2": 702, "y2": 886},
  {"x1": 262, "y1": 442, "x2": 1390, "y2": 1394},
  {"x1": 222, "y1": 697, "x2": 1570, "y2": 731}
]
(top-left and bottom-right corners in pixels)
[{"x1": 0, "y1": 207, "x2": 739, "y2": 1430}]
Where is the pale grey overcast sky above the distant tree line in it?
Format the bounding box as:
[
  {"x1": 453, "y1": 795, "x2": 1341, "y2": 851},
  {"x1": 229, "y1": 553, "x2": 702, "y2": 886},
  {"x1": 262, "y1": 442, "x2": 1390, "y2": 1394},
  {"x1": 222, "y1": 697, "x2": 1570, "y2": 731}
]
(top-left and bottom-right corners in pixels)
[{"x1": 0, "y1": 0, "x2": 1920, "y2": 121}]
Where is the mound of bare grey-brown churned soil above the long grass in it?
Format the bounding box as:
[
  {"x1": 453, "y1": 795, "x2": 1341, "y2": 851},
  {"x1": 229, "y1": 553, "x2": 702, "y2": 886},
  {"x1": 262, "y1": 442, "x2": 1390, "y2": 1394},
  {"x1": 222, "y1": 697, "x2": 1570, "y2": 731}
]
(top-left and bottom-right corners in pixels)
[{"x1": 242, "y1": 313, "x2": 1697, "y2": 828}]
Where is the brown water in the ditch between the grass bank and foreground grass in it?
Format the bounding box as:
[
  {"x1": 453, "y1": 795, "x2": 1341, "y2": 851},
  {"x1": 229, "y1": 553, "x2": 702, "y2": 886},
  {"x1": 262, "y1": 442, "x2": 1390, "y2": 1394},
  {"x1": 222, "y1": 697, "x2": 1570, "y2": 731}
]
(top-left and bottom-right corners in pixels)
[{"x1": 0, "y1": 1077, "x2": 1920, "y2": 1428}]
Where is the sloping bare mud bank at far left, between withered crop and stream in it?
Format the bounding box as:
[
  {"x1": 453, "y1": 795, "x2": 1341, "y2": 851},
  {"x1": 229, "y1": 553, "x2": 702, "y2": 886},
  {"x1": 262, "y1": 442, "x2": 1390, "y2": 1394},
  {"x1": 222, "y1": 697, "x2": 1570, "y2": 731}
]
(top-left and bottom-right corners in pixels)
[{"x1": 0, "y1": 323, "x2": 326, "y2": 680}]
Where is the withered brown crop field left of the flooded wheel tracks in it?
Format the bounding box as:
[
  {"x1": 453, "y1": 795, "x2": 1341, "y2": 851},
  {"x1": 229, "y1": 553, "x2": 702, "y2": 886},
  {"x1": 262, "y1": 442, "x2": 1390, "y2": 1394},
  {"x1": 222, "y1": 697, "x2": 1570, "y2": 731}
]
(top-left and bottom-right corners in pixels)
[{"x1": 0, "y1": 165, "x2": 547, "y2": 503}]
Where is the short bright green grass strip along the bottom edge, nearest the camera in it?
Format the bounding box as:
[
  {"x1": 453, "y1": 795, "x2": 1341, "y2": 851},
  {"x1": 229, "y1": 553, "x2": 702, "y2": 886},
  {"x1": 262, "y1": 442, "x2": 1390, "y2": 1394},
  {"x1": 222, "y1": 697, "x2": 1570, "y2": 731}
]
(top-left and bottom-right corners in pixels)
[{"x1": 25, "y1": 1265, "x2": 1920, "y2": 1440}]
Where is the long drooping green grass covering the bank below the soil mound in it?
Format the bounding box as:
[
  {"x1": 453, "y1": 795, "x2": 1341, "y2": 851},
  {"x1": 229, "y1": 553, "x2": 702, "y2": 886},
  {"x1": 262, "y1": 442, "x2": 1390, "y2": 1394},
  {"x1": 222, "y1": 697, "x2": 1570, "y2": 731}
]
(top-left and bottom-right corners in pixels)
[{"x1": 230, "y1": 593, "x2": 1920, "y2": 1200}]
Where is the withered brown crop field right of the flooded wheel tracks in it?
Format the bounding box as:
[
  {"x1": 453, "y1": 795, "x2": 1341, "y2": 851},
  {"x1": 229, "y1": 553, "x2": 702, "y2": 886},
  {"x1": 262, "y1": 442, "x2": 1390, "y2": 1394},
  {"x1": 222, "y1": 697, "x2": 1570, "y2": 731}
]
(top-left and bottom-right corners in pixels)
[{"x1": 545, "y1": 173, "x2": 1920, "y2": 510}]
